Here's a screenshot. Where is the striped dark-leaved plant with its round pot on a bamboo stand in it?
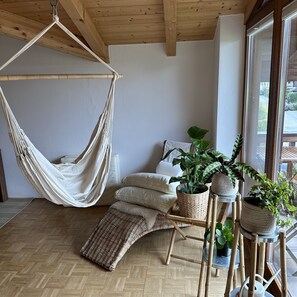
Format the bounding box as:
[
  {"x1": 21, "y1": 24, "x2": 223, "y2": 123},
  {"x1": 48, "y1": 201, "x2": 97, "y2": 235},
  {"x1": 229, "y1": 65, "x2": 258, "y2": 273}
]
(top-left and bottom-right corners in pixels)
[{"x1": 203, "y1": 134, "x2": 258, "y2": 196}]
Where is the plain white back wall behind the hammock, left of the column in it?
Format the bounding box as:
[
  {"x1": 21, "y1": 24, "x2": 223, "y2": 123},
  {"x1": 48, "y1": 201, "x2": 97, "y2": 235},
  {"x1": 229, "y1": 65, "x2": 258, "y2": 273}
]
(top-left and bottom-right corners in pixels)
[{"x1": 0, "y1": 36, "x2": 214, "y2": 197}]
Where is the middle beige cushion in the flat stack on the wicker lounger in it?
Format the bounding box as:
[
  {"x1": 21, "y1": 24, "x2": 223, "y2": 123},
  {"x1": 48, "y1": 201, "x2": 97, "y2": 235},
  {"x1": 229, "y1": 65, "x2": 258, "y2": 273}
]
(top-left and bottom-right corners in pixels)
[{"x1": 115, "y1": 187, "x2": 176, "y2": 213}]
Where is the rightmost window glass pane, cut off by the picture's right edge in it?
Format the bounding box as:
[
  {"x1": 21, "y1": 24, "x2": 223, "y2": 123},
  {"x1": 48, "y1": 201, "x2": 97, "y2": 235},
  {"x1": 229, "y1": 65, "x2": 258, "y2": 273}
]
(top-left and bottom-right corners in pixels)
[{"x1": 273, "y1": 12, "x2": 297, "y2": 296}]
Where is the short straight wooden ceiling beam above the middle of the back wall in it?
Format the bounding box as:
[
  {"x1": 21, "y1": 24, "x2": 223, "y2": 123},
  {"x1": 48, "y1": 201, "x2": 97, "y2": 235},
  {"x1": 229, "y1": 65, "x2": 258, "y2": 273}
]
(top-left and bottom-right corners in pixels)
[{"x1": 163, "y1": 0, "x2": 177, "y2": 56}]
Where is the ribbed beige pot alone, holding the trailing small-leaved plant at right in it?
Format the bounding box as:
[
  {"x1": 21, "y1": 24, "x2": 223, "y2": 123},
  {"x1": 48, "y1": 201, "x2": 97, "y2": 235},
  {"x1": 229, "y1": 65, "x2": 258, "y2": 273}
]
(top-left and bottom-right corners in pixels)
[{"x1": 240, "y1": 197, "x2": 276, "y2": 235}]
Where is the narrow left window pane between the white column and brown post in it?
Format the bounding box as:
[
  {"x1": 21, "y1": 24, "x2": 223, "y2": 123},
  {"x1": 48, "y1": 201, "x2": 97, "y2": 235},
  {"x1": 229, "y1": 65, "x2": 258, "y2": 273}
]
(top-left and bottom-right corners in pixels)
[{"x1": 244, "y1": 22, "x2": 273, "y2": 194}]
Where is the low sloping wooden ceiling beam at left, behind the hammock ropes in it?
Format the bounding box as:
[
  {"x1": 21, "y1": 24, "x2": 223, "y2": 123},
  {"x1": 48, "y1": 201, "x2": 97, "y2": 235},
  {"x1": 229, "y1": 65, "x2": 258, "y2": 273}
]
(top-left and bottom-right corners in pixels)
[{"x1": 0, "y1": 10, "x2": 94, "y2": 60}]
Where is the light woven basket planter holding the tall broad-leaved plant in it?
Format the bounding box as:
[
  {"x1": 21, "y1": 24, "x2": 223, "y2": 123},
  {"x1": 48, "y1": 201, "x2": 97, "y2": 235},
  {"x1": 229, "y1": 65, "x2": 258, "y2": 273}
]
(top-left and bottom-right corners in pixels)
[{"x1": 176, "y1": 187, "x2": 209, "y2": 220}]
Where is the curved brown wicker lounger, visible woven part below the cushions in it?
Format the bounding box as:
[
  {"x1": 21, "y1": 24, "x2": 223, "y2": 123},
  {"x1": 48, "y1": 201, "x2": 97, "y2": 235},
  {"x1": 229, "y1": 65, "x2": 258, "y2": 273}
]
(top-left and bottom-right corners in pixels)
[{"x1": 80, "y1": 208, "x2": 172, "y2": 271}]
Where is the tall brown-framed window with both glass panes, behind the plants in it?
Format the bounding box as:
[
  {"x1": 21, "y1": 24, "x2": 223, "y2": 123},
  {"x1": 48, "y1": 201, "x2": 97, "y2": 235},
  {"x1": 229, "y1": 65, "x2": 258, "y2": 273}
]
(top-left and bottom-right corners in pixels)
[{"x1": 243, "y1": 0, "x2": 297, "y2": 297}]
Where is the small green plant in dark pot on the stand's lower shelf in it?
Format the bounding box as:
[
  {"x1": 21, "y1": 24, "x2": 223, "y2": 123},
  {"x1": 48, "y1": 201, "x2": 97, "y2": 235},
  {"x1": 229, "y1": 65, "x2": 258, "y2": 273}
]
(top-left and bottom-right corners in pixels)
[{"x1": 204, "y1": 219, "x2": 234, "y2": 257}]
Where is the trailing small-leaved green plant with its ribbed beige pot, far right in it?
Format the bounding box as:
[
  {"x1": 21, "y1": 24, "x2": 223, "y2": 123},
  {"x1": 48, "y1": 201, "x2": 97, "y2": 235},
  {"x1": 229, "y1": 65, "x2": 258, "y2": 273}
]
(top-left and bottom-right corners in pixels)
[{"x1": 240, "y1": 174, "x2": 297, "y2": 235}]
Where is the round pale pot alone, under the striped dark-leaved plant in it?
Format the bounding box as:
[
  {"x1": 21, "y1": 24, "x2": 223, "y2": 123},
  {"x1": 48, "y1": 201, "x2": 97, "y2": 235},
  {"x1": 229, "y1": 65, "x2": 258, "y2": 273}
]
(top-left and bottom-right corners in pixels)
[{"x1": 211, "y1": 173, "x2": 238, "y2": 196}]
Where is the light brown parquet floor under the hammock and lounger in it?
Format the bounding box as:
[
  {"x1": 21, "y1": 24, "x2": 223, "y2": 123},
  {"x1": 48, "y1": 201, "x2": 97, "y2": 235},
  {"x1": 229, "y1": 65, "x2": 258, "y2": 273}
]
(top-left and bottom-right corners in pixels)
[{"x1": 0, "y1": 199, "x2": 226, "y2": 297}]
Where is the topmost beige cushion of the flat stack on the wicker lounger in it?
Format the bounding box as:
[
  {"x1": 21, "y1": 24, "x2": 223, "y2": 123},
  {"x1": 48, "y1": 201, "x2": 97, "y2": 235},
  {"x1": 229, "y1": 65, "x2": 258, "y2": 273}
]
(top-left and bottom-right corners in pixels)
[{"x1": 123, "y1": 172, "x2": 178, "y2": 194}]
